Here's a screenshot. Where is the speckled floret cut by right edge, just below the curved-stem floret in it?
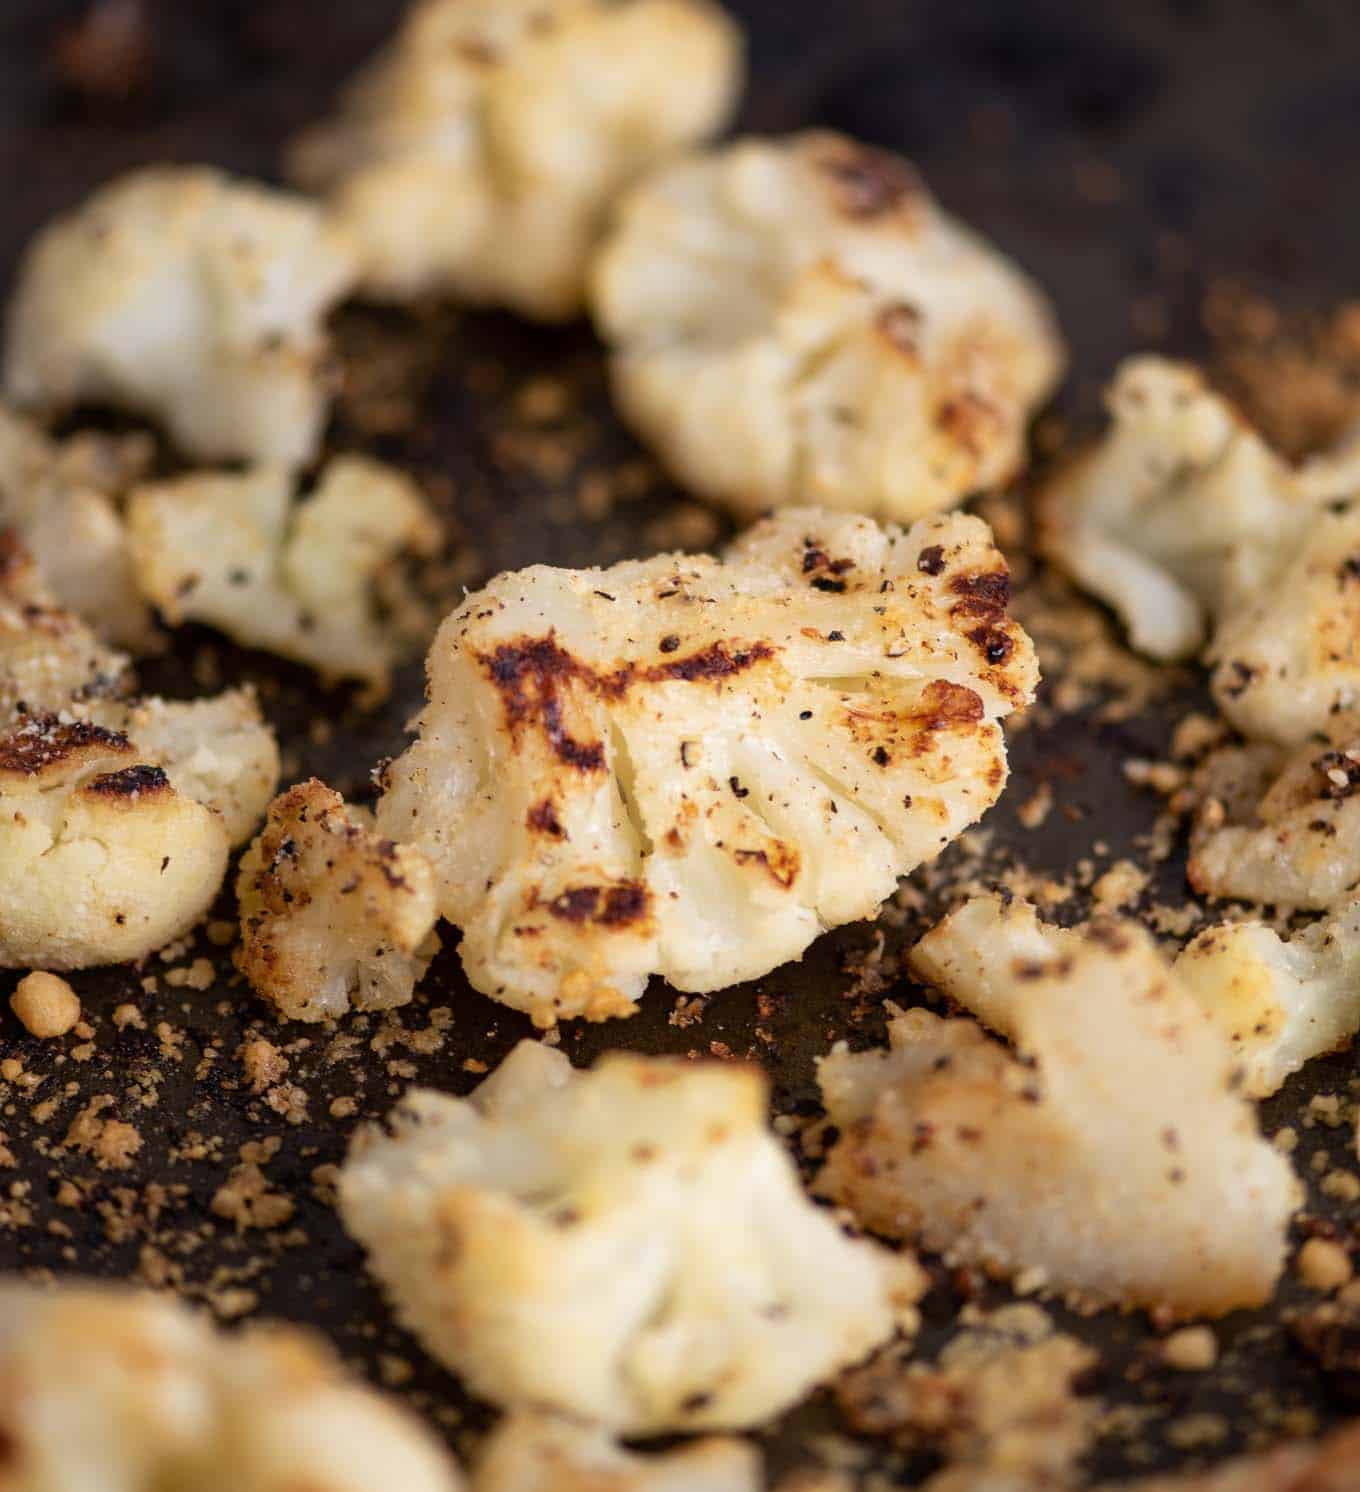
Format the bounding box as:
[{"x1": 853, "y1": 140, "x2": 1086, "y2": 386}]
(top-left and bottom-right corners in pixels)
[{"x1": 1208, "y1": 507, "x2": 1360, "y2": 746}]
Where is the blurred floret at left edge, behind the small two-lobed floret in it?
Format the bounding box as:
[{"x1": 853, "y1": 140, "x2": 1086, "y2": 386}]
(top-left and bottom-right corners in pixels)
[{"x1": 0, "y1": 404, "x2": 157, "y2": 649}]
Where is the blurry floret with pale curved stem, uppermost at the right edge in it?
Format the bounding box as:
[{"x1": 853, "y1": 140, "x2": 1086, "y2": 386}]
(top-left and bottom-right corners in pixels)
[{"x1": 1038, "y1": 357, "x2": 1360, "y2": 659}]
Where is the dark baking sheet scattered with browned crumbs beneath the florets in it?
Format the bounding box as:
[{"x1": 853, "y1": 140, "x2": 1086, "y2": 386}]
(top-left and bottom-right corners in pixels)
[{"x1": 0, "y1": 0, "x2": 1360, "y2": 1474}]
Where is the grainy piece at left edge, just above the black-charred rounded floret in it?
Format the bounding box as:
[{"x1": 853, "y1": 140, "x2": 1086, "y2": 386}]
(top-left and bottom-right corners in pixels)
[{"x1": 0, "y1": 530, "x2": 131, "y2": 730}]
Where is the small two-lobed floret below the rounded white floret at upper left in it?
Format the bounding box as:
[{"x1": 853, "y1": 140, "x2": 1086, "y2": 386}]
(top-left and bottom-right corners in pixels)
[{"x1": 128, "y1": 457, "x2": 440, "y2": 694}]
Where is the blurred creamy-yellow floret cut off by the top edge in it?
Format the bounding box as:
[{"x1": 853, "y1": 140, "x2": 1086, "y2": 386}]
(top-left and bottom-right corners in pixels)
[{"x1": 291, "y1": 0, "x2": 743, "y2": 319}]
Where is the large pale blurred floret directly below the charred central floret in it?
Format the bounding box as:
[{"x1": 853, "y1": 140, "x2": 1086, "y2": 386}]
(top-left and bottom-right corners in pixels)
[{"x1": 340, "y1": 1041, "x2": 923, "y2": 1435}]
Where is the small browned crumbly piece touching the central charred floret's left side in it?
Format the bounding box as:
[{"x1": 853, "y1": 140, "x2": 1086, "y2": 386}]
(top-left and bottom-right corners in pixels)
[{"x1": 236, "y1": 777, "x2": 438, "y2": 1021}]
